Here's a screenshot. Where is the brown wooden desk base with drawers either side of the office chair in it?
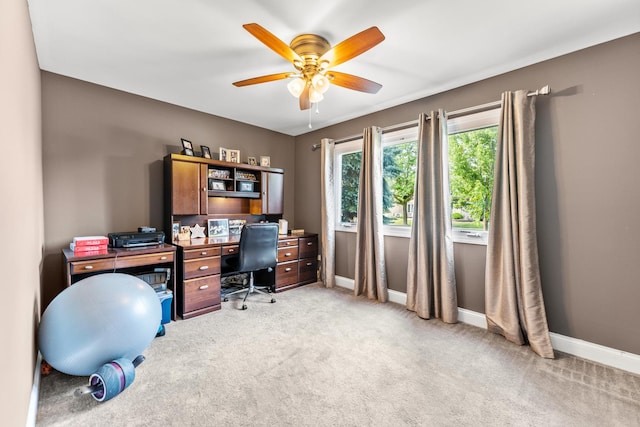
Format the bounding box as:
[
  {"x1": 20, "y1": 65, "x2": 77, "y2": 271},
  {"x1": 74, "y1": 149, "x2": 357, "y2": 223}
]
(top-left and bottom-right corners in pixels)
[{"x1": 174, "y1": 234, "x2": 318, "y2": 319}]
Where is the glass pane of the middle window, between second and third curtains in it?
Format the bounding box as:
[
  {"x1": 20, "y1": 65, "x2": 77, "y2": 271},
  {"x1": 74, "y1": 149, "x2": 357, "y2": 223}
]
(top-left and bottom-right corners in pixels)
[{"x1": 382, "y1": 141, "x2": 417, "y2": 225}]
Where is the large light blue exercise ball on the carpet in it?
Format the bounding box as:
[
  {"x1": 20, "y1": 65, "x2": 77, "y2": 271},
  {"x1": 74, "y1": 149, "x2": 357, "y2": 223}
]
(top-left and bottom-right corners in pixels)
[{"x1": 38, "y1": 273, "x2": 162, "y2": 375}]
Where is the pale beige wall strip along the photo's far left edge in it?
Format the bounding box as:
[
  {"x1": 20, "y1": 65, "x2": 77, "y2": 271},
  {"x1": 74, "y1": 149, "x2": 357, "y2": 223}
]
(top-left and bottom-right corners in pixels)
[{"x1": 0, "y1": 0, "x2": 44, "y2": 426}]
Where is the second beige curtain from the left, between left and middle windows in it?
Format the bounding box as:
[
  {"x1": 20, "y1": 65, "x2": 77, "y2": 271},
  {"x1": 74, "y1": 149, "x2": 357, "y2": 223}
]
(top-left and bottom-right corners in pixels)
[{"x1": 354, "y1": 127, "x2": 388, "y2": 302}]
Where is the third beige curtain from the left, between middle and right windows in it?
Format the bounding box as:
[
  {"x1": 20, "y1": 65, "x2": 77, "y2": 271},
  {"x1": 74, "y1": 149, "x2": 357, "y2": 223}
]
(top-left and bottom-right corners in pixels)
[{"x1": 407, "y1": 110, "x2": 458, "y2": 323}]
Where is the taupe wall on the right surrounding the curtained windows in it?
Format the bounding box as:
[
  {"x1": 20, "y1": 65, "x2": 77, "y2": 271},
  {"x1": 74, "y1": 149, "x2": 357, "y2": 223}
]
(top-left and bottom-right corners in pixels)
[{"x1": 295, "y1": 34, "x2": 640, "y2": 354}]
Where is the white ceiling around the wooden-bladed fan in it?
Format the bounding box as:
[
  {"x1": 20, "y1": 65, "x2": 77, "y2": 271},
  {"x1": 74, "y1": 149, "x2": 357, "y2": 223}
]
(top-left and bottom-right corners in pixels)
[{"x1": 28, "y1": 0, "x2": 640, "y2": 135}]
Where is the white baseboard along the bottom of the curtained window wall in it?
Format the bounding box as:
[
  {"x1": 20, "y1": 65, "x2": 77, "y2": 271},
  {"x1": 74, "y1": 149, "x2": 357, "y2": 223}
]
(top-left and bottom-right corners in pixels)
[{"x1": 336, "y1": 276, "x2": 640, "y2": 375}]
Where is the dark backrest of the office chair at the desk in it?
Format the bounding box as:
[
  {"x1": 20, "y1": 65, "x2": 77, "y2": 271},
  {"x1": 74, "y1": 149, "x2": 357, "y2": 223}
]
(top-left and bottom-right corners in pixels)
[{"x1": 237, "y1": 223, "x2": 279, "y2": 272}]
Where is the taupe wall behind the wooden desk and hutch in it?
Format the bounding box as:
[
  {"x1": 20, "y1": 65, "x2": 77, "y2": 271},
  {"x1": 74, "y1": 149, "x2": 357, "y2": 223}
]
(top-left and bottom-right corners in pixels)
[{"x1": 42, "y1": 72, "x2": 295, "y2": 306}]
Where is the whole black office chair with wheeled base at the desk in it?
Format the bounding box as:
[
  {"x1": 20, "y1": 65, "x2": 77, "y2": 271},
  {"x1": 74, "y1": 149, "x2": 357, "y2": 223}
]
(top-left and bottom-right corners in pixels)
[{"x1": 224, "y1": 223, "x2": 279, "y2": 310}]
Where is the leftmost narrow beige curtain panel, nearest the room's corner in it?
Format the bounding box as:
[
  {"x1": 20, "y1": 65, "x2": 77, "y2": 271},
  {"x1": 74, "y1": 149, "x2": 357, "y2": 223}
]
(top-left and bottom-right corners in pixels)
[{"x1": 320, "y1": 138, "x2": 336, "y2": 288}]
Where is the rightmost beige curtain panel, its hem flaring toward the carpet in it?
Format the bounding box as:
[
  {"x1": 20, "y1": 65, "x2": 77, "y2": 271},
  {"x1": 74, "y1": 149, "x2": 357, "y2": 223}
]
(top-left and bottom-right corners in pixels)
[{"x1": 485, "y1": 91, "x2": 554, "y2": 359}]
